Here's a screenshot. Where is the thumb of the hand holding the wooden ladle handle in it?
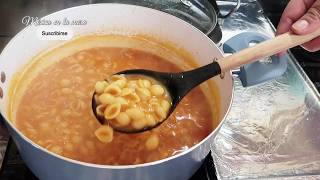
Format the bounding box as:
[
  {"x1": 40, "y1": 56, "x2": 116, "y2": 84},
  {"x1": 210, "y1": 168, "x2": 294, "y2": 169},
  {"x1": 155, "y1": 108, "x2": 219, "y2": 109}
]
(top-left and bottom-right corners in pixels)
[{"x1": 291, "y1": 0, "x2": 320, "y2": 34}]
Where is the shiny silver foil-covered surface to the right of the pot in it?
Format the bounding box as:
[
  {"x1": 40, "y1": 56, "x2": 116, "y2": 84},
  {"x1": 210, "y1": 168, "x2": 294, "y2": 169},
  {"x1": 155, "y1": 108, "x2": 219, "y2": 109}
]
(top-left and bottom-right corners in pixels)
[{"x1": 212, "y1": 0, "x2": 320, "y2": 179}]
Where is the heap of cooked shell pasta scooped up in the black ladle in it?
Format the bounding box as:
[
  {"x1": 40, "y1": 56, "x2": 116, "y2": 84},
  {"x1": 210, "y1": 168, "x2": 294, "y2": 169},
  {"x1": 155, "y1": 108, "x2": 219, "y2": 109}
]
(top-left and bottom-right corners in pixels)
[{"x1": 94, "y1": 75, "x2": 171, "y2": 135}]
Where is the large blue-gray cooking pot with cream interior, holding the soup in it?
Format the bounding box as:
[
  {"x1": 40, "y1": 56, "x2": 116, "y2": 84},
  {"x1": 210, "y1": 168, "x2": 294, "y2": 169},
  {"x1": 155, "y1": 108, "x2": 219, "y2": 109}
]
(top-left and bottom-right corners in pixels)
[{"x1": 0, "y1": 4, "x2": 285, "y2": 180}]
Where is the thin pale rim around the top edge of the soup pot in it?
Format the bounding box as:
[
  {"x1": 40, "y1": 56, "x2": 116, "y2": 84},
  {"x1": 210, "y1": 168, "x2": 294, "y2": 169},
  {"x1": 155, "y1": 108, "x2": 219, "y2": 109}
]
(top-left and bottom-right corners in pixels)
[{"x1": 0, "y1": 3, "x2": 234, "y2": 170}]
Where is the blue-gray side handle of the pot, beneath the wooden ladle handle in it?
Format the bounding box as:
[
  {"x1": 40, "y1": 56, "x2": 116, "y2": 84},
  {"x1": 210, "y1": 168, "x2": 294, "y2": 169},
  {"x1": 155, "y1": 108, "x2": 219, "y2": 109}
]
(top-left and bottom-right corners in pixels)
[{"x1": 223, "y1": 32, "x2": 287, "y2": 87}]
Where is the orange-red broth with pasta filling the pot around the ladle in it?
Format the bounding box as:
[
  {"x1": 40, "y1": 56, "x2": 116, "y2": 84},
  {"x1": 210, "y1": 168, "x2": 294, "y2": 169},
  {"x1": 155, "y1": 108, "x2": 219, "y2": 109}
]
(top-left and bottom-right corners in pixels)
[{"x1": 10, "y1": 34, "x2": 217, "y2": 165}]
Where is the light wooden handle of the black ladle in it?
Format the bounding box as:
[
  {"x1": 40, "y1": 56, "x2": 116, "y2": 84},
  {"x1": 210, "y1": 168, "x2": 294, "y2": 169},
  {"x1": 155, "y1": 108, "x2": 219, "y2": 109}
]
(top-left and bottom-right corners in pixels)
[{"x1": 218, "y1": 28, "x2": 320, "y2": 72}]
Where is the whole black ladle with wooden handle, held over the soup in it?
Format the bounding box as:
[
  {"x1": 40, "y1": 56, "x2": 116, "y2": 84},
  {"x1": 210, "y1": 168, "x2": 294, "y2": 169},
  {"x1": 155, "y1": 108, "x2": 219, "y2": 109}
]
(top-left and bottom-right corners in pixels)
[{"x1": 92, "y1": 29, "x2": 320, "y2": 133}]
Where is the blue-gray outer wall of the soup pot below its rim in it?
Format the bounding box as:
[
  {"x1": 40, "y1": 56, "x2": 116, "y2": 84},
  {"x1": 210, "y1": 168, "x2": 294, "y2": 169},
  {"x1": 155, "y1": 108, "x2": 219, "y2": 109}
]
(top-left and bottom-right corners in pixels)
[{"x1": 5, "y1": 121, "x2": 213, "y2": 180}]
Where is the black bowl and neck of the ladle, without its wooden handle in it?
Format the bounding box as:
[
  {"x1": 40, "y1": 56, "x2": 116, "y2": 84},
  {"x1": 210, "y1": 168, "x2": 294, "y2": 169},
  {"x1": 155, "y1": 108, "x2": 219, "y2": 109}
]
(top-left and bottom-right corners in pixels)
[{"x1": 92, "y1": 62, "x2": 221, "y2": 133}]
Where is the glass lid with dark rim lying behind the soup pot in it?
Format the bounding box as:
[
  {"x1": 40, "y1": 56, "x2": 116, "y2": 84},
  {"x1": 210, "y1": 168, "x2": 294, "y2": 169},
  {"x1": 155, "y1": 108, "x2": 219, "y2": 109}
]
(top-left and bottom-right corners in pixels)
[{"x1": 98, "y1": 0, "x2": 241, "y2": 43}]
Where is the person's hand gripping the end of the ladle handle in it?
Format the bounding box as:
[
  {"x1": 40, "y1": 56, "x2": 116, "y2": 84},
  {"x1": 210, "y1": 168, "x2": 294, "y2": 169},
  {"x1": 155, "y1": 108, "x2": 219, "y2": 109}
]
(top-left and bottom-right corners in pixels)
[{"x1": 276, "y1": 0, "x2": 320, "y2": 52}]
